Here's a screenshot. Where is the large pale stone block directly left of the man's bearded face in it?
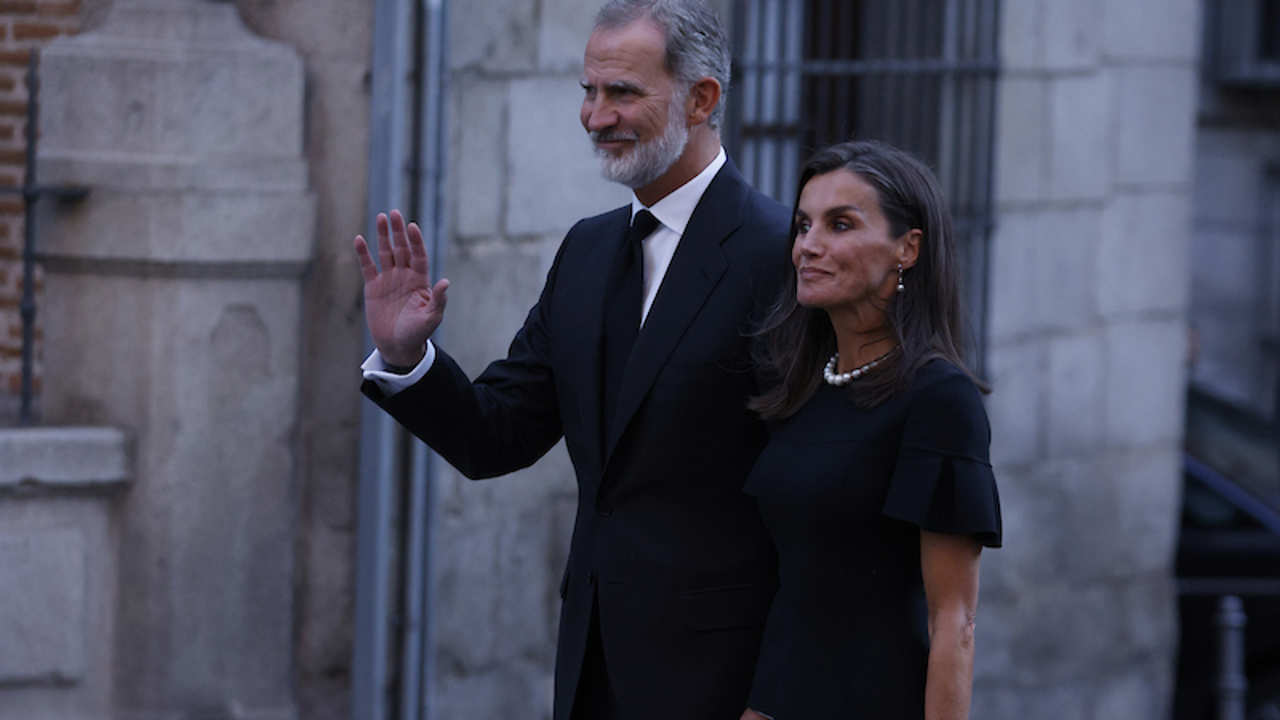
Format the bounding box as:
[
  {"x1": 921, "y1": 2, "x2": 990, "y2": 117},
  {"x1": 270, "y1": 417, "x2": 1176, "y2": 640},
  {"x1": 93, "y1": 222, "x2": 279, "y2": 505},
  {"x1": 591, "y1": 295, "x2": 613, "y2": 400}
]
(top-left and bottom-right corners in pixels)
[{"x1": 506, "y1": 76, "x2": 631, "y2": 234}]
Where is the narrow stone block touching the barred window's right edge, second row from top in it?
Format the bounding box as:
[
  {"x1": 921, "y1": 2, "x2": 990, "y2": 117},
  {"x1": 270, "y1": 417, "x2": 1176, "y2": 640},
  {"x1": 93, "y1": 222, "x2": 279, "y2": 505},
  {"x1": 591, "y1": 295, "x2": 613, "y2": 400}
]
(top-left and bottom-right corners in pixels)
[{"x1": 996, "y1": 77, "x2": 1048, "y2": 205}]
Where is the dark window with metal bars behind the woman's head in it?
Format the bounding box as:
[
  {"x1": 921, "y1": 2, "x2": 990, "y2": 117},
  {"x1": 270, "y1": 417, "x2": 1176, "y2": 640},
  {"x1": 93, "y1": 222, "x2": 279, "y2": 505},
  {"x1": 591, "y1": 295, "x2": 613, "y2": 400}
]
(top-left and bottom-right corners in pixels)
[{"x1": 726, "y1": 0, "x2": 1000, "y2": 368}]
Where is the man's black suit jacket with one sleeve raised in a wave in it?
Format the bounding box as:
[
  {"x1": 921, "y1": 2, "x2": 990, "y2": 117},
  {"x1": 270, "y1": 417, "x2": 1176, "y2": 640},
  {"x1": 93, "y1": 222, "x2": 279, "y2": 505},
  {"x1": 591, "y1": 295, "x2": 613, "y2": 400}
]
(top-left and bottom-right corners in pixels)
[{"x1": 364, "y1": 163, "x2": 790, "y2": 720}]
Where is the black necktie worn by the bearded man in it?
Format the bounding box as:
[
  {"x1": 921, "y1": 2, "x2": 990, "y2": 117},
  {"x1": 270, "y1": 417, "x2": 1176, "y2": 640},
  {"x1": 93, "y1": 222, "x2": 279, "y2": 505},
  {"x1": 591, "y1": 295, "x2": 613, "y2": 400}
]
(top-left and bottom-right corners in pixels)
[{"x1": 602, "y1": 210, "x2": 658, "y2": 442}]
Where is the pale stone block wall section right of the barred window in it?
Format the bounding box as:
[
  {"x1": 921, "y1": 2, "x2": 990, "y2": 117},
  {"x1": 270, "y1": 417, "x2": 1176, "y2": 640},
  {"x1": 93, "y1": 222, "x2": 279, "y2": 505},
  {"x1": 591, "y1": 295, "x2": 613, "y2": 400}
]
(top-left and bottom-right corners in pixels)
[{"x1": 973, "y1": 0, "x2": 1201, "y2": 720}]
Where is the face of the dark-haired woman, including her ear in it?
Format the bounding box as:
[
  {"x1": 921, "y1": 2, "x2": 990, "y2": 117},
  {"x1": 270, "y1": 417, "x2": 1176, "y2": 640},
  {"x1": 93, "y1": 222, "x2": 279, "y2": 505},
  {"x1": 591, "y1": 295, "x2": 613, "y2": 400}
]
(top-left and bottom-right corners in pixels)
[{"x1": 791, "y1": 169, "x2": 919, "y2": 315}]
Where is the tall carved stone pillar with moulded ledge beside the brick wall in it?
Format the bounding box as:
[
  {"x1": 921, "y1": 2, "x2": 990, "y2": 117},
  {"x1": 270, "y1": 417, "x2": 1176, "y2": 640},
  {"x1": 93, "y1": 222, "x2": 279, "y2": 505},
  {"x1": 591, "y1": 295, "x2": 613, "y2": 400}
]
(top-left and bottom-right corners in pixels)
[{"x1": 40, "y1": 0, "x2": 315, "y2": 720}]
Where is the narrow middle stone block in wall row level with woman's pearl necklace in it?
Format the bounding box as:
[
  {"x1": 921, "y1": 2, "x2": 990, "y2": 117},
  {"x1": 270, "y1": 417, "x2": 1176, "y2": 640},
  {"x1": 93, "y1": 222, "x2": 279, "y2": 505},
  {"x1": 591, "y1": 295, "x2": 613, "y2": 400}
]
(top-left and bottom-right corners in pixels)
[{"x1": 1044, "y1": 331, "x2": 1106, "y2": 457}]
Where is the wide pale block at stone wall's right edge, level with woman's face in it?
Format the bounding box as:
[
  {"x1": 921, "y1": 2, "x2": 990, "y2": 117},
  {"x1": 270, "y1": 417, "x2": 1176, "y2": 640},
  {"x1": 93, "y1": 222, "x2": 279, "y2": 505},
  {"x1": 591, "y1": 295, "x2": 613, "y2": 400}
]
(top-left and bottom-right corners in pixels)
[{"x1": 1097, "y1": 192, "x2": 1187, "y2": 315}]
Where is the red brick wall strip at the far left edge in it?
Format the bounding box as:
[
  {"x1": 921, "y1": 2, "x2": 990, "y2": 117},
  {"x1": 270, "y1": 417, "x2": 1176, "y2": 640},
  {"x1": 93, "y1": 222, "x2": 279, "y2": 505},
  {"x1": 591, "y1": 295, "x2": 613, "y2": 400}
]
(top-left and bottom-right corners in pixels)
[{"x1": 0, "y1": 0, "x2": 79, "y2": 404}]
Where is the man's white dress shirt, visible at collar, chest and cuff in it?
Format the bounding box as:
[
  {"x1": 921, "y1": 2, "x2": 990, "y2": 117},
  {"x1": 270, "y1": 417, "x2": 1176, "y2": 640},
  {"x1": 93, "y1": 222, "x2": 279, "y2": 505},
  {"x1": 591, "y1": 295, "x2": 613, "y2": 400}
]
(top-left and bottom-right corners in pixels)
[{"x1": 360, "y1": 147, "x2": 726, "y2": 395}]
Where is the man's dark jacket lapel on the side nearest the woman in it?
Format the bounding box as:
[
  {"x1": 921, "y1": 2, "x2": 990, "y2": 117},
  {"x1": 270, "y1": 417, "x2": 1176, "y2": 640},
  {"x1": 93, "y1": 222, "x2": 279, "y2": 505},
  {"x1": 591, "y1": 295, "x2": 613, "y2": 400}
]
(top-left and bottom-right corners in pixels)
[{"x1": 596, "y1": 160, "x2": 748, "y2": 462}]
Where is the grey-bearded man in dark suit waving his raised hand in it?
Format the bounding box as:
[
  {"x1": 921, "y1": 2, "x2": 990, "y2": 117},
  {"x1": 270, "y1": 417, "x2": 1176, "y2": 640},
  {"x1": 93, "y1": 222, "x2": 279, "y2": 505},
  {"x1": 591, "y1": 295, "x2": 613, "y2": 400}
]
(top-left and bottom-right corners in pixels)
[{"x1": 356, "y1": 0, "x2": 790, "y2": 720}]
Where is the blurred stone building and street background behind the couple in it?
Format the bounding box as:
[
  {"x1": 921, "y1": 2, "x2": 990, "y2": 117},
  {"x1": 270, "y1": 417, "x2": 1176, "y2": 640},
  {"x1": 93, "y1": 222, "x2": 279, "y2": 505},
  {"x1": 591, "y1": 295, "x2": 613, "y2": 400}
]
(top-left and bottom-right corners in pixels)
[{"x1": 0, "y1": 0, "x2": 1280, "y2": 720}]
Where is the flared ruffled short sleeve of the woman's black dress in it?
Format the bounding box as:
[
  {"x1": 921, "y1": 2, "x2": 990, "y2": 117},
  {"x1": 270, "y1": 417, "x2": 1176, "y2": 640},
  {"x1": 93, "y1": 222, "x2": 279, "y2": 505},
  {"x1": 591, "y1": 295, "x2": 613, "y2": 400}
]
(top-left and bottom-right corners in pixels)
[{"x1": 881, "y1": 369, "x2": 1001, "y2": 547}]
